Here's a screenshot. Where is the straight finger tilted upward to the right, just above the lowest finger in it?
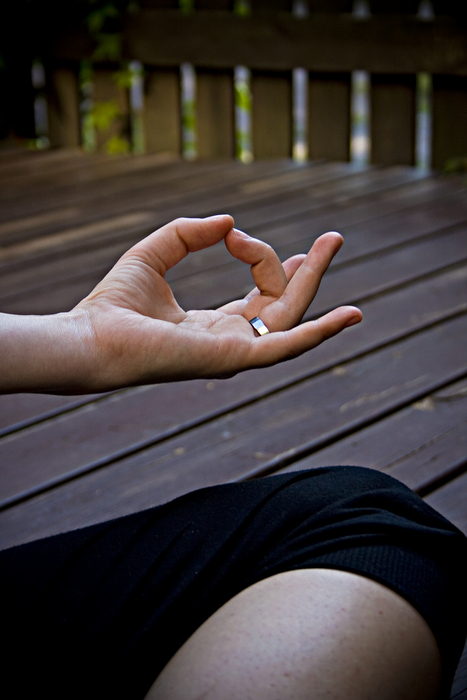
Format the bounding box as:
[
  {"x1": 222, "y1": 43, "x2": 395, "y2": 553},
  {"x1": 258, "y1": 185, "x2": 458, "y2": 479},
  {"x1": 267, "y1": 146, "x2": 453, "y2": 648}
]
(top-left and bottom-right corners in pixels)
[{"x1": 256, "y1": 231, "x2": 343, "y2": 330}]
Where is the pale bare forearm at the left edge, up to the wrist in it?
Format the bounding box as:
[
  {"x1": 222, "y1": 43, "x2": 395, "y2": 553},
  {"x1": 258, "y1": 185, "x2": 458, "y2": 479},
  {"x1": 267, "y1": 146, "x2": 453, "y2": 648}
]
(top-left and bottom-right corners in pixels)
[{"x1": 0, "y1": 311, "x2": 93, "y2": 394}]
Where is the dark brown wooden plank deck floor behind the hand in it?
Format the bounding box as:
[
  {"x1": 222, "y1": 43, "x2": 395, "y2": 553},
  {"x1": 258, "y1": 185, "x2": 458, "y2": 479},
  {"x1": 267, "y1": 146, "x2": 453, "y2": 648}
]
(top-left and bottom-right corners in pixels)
[{"x1": 0, "y1": 151, "x2": 467, "y2": 700}]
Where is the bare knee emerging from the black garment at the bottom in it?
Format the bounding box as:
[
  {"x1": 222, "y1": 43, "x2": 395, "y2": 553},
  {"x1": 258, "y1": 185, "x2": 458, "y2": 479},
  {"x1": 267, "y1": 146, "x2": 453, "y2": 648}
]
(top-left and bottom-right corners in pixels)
[{"x1": 146, "y1": 569, "x2": 441, "y2": 700}]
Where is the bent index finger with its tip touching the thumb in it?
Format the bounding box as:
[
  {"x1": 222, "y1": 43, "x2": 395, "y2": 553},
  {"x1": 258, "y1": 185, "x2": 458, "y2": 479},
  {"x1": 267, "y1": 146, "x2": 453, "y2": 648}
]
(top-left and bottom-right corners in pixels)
[{"x1": 225, "y1": 229, "x2": 287, "y2": 299}]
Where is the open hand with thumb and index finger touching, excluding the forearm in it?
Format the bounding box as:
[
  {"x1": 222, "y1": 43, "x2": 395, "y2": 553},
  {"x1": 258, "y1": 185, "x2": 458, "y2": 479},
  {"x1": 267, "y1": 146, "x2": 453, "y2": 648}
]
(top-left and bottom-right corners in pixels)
[{"x1": 71, "y1": 216, "x2": 361, "y2": 391}]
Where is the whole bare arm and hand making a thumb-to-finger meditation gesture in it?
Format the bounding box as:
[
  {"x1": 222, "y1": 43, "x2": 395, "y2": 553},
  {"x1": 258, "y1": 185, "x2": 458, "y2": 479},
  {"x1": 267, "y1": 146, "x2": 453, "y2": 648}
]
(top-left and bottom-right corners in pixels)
[{"x1": 0, "y1": 215, "x2": 361, "y2": 393}]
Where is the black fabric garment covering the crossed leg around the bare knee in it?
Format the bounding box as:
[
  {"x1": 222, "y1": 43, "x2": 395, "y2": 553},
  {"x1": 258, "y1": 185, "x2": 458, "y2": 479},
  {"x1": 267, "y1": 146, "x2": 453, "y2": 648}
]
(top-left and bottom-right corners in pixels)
[{"x1": 0, "y1": 467, "x2": 467, "y2": 700}]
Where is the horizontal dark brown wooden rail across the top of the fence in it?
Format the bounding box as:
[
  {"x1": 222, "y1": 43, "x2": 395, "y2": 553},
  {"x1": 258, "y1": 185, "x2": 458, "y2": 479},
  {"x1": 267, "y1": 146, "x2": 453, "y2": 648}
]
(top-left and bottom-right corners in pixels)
[{"x1": 52, "y1": 10, "x2": 467, "y2": 75}]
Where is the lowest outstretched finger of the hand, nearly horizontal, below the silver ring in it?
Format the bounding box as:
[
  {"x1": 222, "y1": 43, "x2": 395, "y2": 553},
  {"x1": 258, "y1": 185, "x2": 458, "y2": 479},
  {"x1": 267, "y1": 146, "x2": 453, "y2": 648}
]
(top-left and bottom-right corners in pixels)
[{"x1": 243, "y1": 306, "x2": 362, "y2": 367}]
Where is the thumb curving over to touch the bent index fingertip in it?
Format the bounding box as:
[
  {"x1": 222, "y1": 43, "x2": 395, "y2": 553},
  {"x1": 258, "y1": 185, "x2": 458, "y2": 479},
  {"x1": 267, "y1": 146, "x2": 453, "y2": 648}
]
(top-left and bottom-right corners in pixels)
[{"x1": 124, "y1": 214, "x2": 234, "y2": 276}]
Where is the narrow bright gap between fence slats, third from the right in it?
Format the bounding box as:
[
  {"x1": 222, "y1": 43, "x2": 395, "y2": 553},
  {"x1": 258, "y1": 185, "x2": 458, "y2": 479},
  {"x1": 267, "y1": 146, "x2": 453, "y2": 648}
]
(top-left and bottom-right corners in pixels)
[{"x1": 292, "y1": 0, "x2": 308, "y2": 163}]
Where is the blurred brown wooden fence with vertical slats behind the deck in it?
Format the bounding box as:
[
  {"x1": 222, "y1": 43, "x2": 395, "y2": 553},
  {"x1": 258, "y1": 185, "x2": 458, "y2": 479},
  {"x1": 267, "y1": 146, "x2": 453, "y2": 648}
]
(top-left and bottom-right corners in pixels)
[{"x1": 41, "y1": 1, "x2": 467, "y2": 168}]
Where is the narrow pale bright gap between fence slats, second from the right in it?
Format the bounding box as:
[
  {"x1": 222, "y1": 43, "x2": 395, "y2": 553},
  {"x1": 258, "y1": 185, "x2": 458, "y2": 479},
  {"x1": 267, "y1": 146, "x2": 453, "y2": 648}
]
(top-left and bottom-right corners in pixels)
[{"x1": 350, "y1": 0, "x2": 371, "y2": 167}]
